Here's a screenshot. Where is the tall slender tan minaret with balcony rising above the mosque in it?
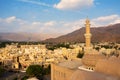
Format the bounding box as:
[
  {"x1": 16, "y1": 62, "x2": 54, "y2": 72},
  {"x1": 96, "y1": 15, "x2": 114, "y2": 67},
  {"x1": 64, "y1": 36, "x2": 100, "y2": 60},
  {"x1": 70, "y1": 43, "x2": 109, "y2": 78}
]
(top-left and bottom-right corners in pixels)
[{"x1": 84, "y1": 18, "x2": 92, "y2": 52}]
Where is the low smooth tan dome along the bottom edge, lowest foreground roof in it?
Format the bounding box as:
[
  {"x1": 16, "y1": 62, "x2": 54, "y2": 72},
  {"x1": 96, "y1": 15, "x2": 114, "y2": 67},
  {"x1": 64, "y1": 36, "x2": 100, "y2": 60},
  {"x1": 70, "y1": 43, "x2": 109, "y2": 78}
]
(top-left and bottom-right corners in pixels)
[{"x1": 70, "y1": 70, "x2": 120, "y2": 80}]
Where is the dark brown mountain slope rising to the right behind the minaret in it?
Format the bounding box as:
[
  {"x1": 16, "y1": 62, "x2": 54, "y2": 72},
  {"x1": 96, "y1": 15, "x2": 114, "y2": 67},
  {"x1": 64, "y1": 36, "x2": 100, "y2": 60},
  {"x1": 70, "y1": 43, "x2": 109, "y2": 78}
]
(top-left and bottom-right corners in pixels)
[{"x1": 43, "y1": 23, "x2": 120, "y2": 43}]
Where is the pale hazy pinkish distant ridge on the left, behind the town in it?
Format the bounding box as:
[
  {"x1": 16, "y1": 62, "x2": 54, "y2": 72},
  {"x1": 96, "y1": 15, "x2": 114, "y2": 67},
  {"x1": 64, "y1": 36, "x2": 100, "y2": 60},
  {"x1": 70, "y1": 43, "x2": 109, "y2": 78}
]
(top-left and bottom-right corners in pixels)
[{"x1": 0, "y1": 32, "x2": 57, "y2": 41}]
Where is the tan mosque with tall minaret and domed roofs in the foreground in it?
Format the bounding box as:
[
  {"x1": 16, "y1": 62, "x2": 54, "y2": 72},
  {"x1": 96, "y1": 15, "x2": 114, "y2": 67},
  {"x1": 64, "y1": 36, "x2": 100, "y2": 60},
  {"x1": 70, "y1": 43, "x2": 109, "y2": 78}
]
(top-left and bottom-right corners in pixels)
[{"x1": 51, "y1": 18, "x2": 120, "y2": 80}]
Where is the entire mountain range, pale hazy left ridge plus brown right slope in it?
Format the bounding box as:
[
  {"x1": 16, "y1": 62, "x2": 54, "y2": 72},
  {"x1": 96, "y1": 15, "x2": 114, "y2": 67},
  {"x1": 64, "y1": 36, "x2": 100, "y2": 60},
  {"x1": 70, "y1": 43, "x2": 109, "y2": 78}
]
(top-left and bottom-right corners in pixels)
[{"x1": 0, "y1": 23, "x2": 120, "y2": 43}]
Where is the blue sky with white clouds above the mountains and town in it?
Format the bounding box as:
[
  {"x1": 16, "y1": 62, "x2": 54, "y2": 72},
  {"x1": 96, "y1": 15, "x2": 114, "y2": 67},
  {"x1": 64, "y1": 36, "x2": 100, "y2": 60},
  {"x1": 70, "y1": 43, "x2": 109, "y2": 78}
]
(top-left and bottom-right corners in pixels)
[{"x1": 0, "y1": 0, "x2": 120, "y2": 34}]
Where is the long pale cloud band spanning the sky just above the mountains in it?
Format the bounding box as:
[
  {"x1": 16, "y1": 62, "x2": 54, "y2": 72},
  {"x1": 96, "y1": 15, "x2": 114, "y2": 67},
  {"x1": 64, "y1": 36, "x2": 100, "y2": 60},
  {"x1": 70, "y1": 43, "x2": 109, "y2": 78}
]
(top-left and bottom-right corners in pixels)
[{"x1": 0, "y1": 14, "x2": 120, "y2": 34}]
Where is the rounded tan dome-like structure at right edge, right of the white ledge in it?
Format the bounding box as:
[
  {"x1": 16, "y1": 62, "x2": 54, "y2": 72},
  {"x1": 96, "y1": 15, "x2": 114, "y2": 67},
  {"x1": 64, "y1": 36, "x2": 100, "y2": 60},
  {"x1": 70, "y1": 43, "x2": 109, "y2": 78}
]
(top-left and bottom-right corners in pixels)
[{"x1": 95, "y1": 57, "x2": 120, "y2": 77}]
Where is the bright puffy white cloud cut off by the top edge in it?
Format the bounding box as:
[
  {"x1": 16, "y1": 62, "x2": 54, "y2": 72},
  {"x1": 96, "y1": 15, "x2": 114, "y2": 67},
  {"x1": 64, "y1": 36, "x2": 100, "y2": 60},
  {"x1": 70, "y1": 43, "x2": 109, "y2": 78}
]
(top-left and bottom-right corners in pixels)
[{"x1": 54, "y1": 0, "x2": 94, "y2": 10}]
